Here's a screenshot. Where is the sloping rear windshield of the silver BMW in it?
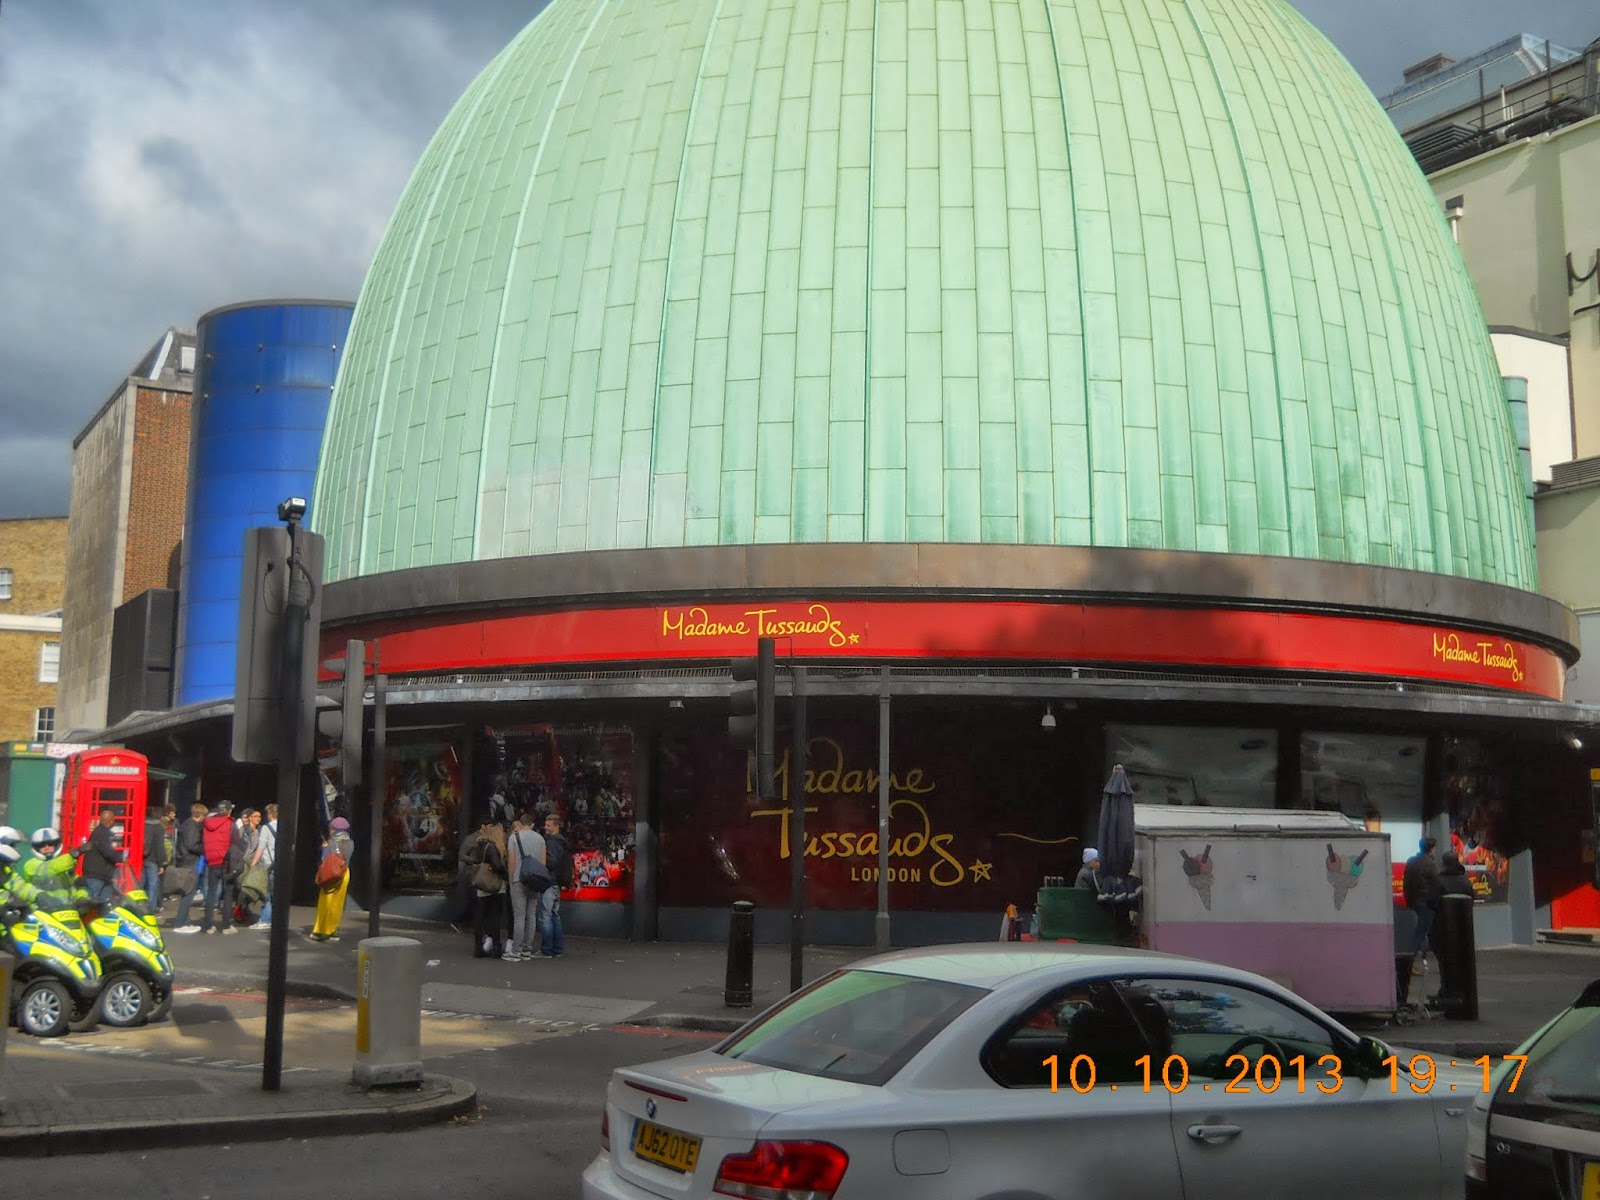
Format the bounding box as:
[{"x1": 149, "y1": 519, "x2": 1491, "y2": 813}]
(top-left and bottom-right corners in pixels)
[{"x1": 717, "y1": 971, "x2": 984, "y2": 1085}]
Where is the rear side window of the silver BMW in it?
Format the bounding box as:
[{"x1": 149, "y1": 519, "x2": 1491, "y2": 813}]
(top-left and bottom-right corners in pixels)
[{"x1": 984, "y1": 982, "x2": 1150, "y2": 1090}]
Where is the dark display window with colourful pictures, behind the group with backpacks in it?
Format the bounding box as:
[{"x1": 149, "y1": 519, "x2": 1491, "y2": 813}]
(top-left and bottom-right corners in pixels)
[{"x1": 485, "y1": 725, "x2": 637, "y2": 901}]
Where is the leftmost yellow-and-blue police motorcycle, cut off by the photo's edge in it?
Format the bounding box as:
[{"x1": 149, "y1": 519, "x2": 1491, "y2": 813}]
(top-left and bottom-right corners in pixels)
[{"x1": 0, "y1": 842, "x2": 102, "y2": 1037}]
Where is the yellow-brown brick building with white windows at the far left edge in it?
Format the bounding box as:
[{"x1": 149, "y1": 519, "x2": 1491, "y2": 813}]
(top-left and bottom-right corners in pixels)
[{"x1": 0, "y1": 517, "x2": 67, "y2": 742}]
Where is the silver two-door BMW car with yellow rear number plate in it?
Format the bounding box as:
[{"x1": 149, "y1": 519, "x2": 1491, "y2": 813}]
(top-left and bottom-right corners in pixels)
[{"x1": 584, "y1": 944, "x2": 1482, "y2": 1200}]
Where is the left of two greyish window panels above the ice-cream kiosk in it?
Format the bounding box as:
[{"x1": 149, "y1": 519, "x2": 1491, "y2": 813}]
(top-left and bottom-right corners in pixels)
[{"x1": 1106, "y1": 725, "x2": 1278, "y2": 808}]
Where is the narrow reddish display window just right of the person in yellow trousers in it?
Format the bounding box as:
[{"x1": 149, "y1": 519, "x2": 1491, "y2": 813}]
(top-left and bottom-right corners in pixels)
[{"x1": 382, "y1": 741, "x2": 461, "y2": 886}]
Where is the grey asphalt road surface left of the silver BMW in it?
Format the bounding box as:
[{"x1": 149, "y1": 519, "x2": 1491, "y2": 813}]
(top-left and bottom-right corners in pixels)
[{"x1": 36, "y1": 994, "x2": 715, "y2": 1200}]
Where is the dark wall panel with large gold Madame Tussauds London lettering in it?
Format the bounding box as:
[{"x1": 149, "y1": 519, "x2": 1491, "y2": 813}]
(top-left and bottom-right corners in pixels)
[{"x1": 659, "y1": 712, "x2": 1099, "y2": 918}]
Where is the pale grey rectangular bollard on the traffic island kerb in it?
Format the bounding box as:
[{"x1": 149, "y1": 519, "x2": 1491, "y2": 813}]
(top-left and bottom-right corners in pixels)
[{"x1": 350, "y1": 938, "x2": 422, "y2": 1088}]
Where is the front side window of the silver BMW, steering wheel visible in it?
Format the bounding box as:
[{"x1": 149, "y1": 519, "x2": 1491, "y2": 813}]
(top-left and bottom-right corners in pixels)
[{"x1": 1117, "y1": 979, "x2": 1352, "y2": 1091}]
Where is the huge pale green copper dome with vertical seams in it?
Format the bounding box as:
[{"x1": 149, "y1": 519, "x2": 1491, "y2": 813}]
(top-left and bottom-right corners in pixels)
[{"x1": 312, "y1": 0, "x2": 1534, "y2": 587}]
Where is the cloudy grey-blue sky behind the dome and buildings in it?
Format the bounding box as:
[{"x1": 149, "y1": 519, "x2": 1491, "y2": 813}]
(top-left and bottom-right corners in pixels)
[{"x1": 0, "y1": 0, "x2": 1600, "y2": 517}]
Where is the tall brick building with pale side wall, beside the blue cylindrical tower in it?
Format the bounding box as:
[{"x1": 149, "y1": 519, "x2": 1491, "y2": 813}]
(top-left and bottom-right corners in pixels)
[{"x1": 56, "y1": 328, "x2": 195, "y2": 731}]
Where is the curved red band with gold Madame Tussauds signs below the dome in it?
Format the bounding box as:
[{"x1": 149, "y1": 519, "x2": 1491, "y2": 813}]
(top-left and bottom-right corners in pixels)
[{"x1": 323, "y1": 600, "x2": 1566, "y2": 699}]
